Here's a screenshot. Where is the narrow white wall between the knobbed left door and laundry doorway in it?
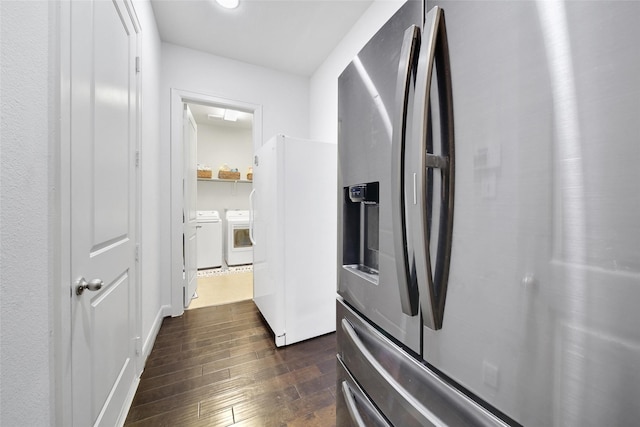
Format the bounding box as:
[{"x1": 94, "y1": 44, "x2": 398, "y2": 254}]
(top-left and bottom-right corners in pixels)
[{"x1": 134, "y1": 0, "x2": 169, "y2": 364}]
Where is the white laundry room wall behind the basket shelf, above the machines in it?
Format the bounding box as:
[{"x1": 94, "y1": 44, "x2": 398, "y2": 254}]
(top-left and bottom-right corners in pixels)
[{"x1": 198, "y1": 122, "x2": 253, "y2": 217}]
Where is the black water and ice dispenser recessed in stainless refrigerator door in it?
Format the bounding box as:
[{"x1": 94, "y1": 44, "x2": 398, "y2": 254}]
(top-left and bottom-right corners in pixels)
[{"x1": 342, "y1": 182, "x2": 380, "y2": 283}]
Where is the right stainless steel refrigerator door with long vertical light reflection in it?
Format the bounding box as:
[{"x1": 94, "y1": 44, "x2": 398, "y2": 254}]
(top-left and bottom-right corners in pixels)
[{"x1": 422, "y1": 0, "x2": 640, "y2": 426}]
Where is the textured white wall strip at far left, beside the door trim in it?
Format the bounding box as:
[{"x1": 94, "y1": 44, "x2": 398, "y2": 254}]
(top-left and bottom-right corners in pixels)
[{"x1": 0, "y1": 0, "x2": 54, "y2": 427}]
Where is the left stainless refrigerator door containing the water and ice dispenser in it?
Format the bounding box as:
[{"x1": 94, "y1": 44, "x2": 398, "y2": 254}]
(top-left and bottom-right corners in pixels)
[{"x1": 338, "y1": 1, "x2": 423, "y2": 352}]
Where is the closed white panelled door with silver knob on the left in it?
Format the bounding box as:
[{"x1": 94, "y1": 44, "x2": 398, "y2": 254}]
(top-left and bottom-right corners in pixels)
[{"x1": 70, "y1": 0, "x2": 138, "y2": 426}]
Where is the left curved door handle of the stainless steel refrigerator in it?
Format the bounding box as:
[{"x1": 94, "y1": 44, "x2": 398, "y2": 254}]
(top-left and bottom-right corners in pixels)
[{"x1": 391, "y1": 25, "x2": 420, "y2": 316}]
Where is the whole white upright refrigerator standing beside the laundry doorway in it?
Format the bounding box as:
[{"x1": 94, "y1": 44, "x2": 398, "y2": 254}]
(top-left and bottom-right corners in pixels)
[{"x1": 250, "y1": 135, "x2": 337, "y2": 347}]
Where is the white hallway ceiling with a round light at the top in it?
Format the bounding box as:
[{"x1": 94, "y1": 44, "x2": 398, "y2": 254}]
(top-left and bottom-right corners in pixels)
[{"x1": 151, "y1": 0, "x2": 373, "y2": 76}]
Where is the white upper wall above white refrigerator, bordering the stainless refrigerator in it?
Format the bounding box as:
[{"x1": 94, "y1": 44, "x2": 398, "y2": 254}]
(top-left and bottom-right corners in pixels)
[{"x1": 309, "y1": 0, "x2": 406, "y2": 143}]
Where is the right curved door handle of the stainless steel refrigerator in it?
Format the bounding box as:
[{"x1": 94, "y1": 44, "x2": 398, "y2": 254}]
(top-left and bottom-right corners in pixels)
[{"x1": 412, "y1": 6, "x2": 455, "y2": 330}]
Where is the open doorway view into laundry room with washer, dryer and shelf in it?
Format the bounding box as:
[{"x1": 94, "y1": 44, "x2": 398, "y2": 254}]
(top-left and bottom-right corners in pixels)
[{"x1": 187, "y1": 103, "x2": 254, "y2": 309}]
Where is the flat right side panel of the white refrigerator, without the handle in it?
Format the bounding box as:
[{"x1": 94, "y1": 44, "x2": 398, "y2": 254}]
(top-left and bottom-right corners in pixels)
[{"x1": 282, "y1": 137, "x2": 337, "y2": 345}]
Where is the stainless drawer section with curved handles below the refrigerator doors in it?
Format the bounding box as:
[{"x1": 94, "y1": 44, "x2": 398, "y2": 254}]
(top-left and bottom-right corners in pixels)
[{"x1": 336, "y1": 301, "x2": 506, "y2": 427}]
